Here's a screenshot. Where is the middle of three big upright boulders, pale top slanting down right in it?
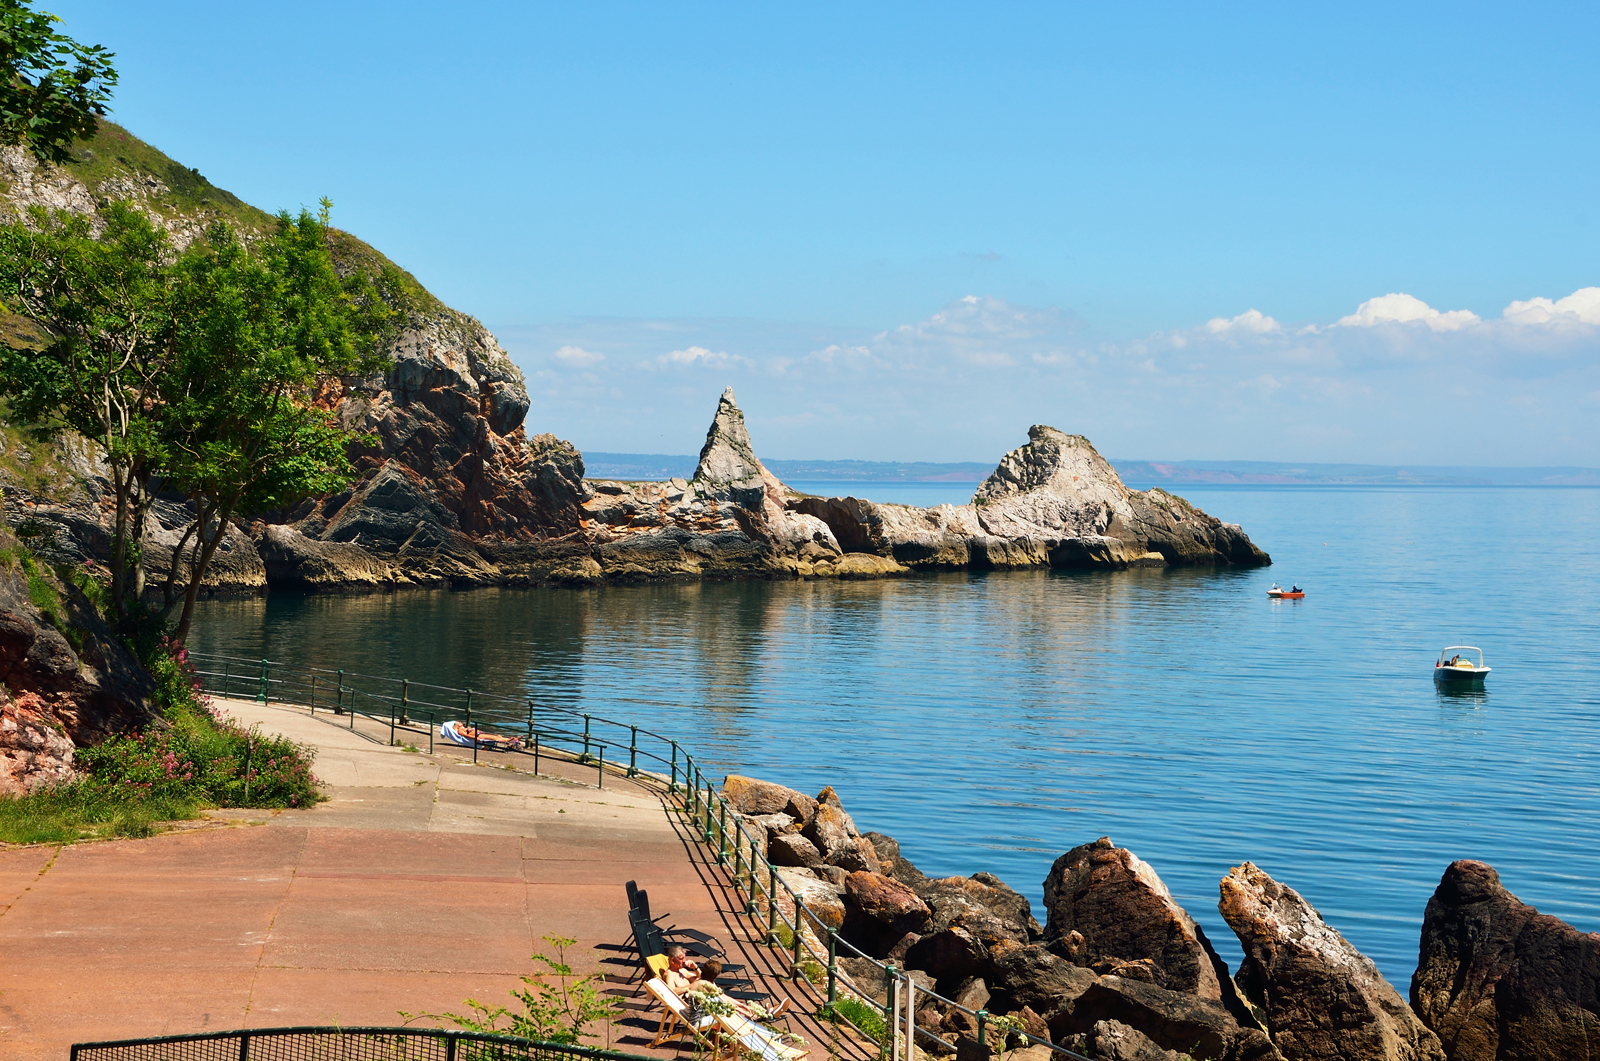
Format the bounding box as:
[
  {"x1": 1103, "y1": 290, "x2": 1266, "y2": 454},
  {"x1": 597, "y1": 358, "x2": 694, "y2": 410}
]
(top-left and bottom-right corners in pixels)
[{"x1": 1218, "y1": 863, "x2": 1445, "y2": 1061}]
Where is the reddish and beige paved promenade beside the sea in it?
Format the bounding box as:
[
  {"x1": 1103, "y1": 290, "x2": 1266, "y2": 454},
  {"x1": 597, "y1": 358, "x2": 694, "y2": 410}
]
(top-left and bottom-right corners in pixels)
[{"x1": 0, "y1": 701, "x2": 858, "y2": 1061}]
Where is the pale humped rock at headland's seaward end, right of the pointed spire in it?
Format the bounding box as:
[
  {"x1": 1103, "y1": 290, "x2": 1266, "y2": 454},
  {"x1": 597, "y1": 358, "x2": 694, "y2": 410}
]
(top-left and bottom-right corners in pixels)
[{"x1": 794, "y1": 424, "x2": 1270, "y2": 568}]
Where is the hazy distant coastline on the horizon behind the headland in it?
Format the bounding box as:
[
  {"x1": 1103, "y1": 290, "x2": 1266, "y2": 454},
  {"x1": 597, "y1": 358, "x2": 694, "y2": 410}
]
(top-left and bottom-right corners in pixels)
[{"x1": 584, "y1": 451, "x2": 1600, "y2": 486}]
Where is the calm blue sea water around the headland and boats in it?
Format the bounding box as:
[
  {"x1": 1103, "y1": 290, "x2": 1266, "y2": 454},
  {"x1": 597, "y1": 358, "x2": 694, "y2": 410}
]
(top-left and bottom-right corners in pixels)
[{"x1": 195, "y1": 483, "x2": 1600, "y2": 991}]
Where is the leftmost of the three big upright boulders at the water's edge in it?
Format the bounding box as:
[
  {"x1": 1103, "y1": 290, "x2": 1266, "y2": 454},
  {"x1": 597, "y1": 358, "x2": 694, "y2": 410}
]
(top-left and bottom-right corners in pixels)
[{"x1": 1045, "y1": 837, "x2": 1248, "y2": 1004}]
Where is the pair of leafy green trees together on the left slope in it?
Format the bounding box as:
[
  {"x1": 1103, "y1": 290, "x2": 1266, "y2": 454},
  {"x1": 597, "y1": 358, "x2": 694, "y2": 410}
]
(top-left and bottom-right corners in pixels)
[{"x1": 0, "y1": 201, "x2": 403, "y2": 643}]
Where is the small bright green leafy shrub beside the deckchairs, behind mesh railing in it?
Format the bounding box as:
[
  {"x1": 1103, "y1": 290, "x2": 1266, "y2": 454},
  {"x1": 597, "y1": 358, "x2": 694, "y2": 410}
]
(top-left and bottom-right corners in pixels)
[{"x1": 400, "y1": 936, "x2": 622, "y2": 1045}]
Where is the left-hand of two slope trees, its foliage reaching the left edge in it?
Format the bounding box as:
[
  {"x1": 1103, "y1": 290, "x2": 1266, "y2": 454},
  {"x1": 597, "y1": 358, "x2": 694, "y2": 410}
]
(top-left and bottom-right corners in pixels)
[{"x1": 0, "y1": 203, "x2": 178, "y2": 619}]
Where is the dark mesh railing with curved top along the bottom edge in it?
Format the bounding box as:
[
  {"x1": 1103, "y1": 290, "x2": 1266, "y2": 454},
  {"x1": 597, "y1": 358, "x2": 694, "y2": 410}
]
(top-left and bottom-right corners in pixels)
[{"x1": 72, "y1": 1027, "x2": 651, "y2": 1061}]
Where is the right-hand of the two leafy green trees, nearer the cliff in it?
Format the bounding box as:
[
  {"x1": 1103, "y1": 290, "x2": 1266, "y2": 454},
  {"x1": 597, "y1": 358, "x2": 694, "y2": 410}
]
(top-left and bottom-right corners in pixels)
[{"x1": 162, "y1": 200, "x2": 402, "y2": 643}]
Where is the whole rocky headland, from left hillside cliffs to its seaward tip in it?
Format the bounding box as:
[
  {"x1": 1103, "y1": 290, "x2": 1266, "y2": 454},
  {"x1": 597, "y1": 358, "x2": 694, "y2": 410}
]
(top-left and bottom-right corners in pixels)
[{"x1": 0, "y1": 123, "x2": 1270, "y2": 591}]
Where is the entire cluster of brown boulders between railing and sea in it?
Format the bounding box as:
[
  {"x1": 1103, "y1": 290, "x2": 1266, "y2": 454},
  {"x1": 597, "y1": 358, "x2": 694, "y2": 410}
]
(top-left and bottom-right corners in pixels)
[{"x1": 723, "y1": 775, "x2": 1600, "y2": 1061}]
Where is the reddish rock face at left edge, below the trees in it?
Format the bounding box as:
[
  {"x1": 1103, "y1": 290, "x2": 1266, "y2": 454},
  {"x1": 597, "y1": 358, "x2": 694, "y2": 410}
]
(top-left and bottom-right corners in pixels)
[{"x1": 0, "y1": 530, "x2": 154, "y2": 795}]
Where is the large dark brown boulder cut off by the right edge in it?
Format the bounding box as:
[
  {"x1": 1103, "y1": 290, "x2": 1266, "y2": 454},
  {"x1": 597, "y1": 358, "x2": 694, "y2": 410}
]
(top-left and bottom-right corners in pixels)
[{"x1": 1411, "y1": 861, "x2": 1600, "y2": 1061}]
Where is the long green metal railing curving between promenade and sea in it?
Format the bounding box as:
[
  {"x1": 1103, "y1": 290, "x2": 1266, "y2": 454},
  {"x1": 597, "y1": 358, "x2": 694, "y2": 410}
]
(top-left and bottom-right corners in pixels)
[{"x1": 189, "y1": 653, "x2": 1088, "y2": 1061}]
